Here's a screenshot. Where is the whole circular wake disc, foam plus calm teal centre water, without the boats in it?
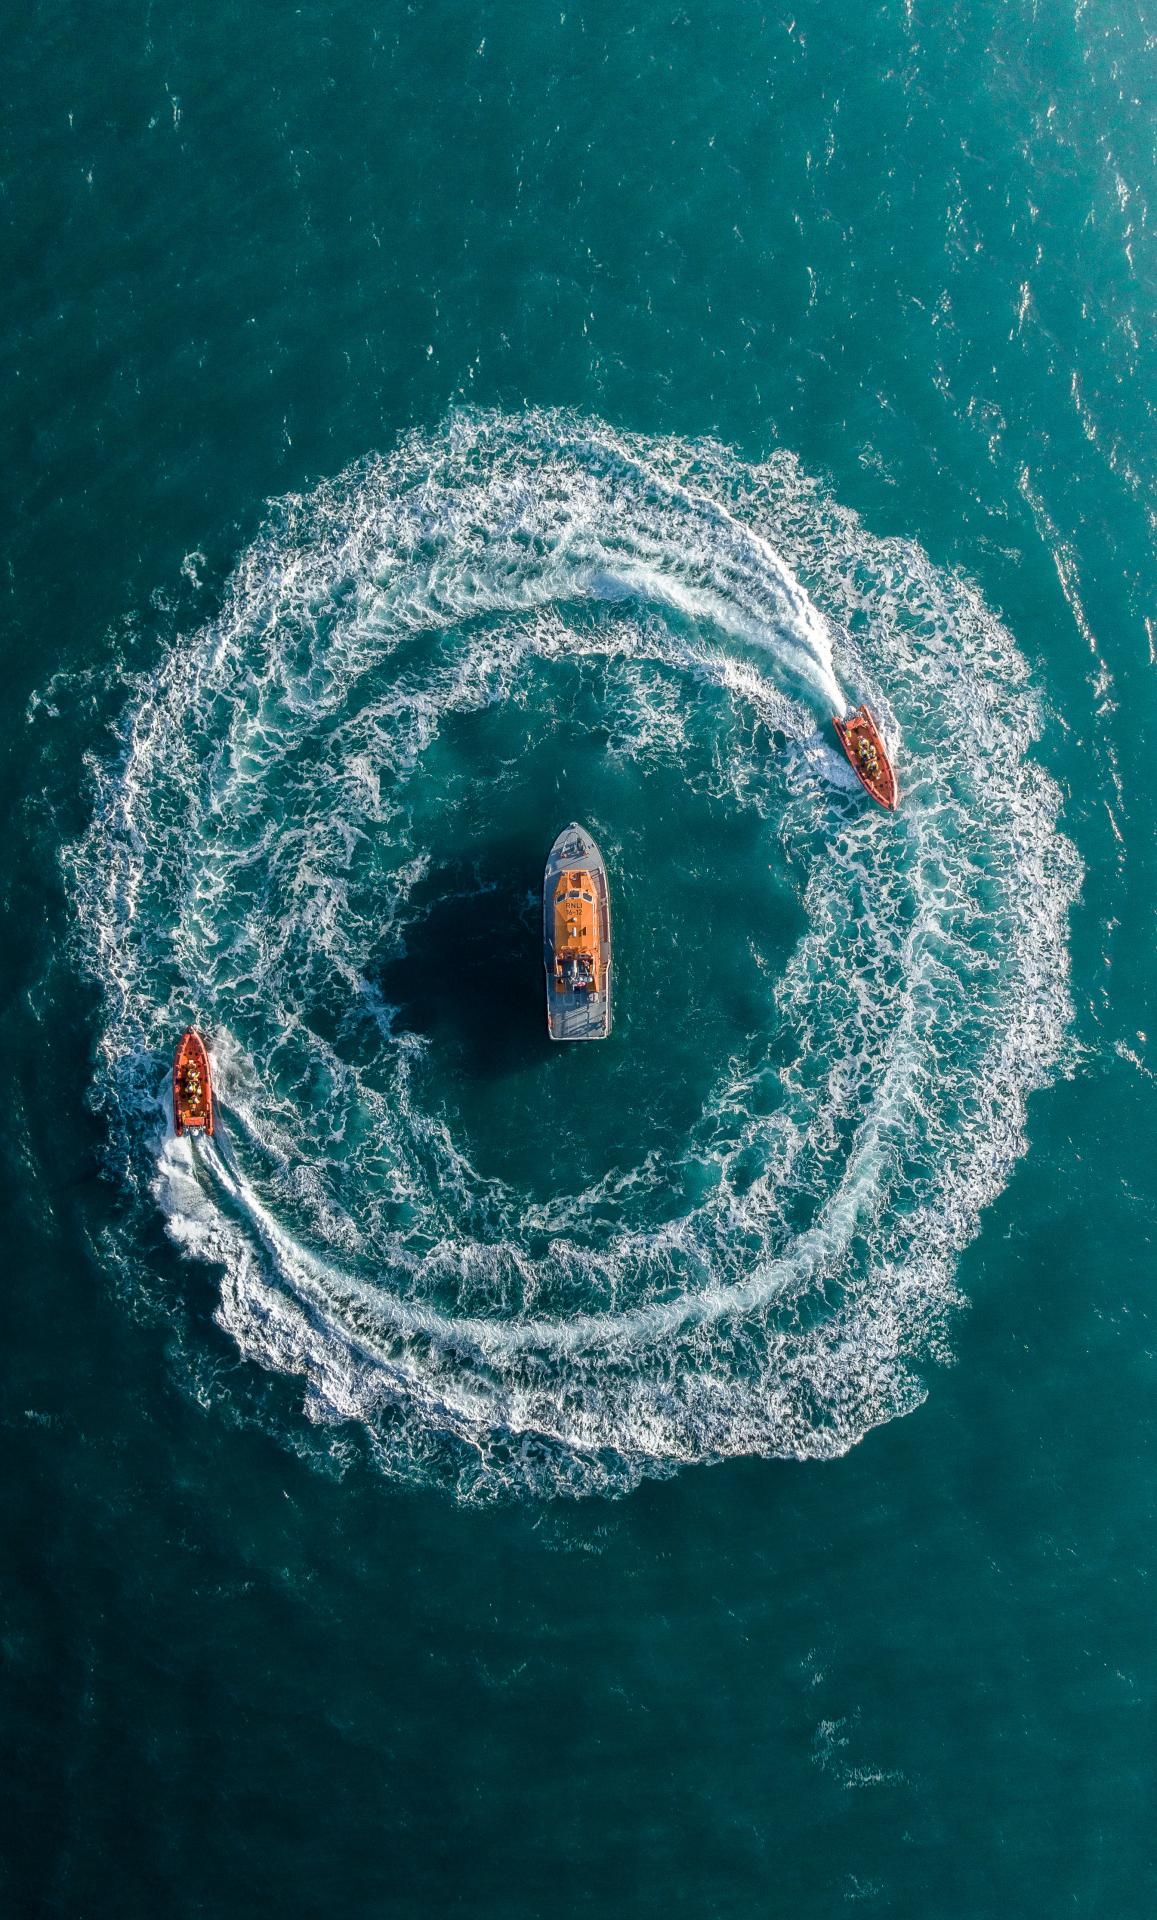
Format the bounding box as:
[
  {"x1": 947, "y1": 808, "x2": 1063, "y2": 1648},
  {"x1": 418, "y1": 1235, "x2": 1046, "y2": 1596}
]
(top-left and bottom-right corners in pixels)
[{"x1": 69, "y1": 413, "x2": 1076, "y2": 1498}]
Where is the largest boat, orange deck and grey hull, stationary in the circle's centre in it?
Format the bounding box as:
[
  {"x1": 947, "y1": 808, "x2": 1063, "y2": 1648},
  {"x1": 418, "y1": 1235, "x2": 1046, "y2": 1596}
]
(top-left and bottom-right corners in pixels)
[{"x1": 543, "y1": 820, "x2": 610, "y2": 1041}]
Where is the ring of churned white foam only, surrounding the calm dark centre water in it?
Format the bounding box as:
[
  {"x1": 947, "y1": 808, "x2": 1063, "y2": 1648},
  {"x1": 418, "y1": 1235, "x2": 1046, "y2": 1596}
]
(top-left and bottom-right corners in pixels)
[{"x1": 67, "y1": 413, "x2": 1078, "y2": 1498}]
